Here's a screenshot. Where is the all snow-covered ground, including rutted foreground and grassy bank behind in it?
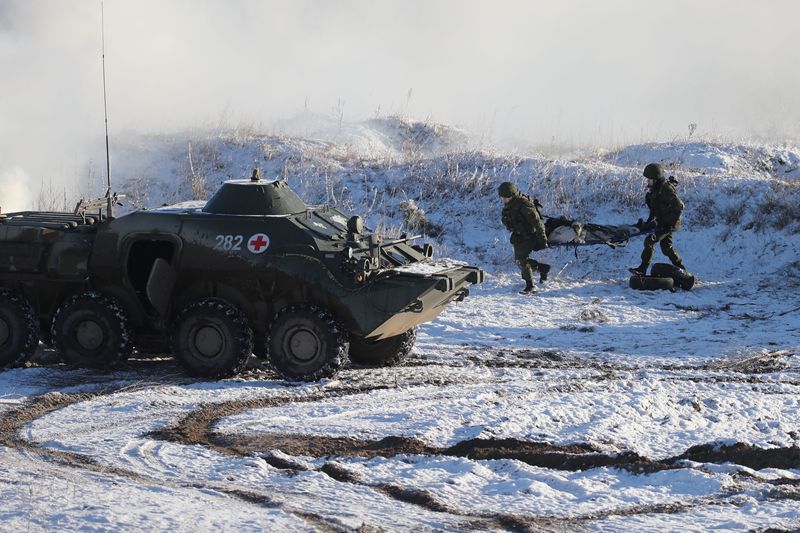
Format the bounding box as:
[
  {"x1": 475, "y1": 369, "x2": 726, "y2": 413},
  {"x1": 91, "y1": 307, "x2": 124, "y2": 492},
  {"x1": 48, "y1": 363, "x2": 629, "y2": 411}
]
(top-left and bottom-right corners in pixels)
[{"x1": 0, "y1": 117, "x2": 800, "y2": 531}]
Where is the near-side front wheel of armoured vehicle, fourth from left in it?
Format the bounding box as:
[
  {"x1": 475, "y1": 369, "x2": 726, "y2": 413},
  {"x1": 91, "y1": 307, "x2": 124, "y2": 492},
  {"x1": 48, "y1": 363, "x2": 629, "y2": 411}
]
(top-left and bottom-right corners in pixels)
[{"x1": 266, "y1": 305, "x2": 349, "y2": 381}]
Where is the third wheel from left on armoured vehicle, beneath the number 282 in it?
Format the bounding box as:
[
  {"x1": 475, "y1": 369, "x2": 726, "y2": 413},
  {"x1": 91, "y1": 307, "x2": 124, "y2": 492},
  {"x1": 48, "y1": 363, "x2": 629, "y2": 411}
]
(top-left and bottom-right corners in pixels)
[{"x1": 172, "y1": 298, "x2": 253, "y2": 379}]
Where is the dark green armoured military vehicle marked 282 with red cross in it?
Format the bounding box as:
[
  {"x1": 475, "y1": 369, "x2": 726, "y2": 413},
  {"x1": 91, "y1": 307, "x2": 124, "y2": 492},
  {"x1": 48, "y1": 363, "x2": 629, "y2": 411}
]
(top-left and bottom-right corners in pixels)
[{"x1": 0, "y1": 171, "x2": 484, "y2": 380}]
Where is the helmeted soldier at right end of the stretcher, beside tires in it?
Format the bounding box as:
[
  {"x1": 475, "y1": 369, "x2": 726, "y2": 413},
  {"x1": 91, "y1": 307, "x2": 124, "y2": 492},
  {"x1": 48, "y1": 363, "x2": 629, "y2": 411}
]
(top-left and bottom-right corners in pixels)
[{"x1": 628, "y1": 163, "x2": 684, "y2": 276}]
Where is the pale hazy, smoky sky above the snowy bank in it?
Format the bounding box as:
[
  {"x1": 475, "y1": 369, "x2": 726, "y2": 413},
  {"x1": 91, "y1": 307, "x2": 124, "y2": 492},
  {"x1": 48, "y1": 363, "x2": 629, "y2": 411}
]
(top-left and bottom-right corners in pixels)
[{"x1": 0, "y1": 0, "x2": 800, "y2": 206}]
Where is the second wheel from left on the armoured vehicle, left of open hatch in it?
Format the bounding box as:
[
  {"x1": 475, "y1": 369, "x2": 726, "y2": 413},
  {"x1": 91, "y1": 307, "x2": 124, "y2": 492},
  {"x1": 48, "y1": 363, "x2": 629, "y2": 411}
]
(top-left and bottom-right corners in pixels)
[{"x1": 50, "y1": 292, "x2": 133, "y2": 368}]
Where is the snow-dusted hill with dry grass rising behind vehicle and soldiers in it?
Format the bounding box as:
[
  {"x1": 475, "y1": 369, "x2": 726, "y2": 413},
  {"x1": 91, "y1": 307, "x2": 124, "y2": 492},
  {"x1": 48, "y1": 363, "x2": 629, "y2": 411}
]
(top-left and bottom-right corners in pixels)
[{"x1": 113, "y1": 115, "x2": 800, "y2": 276}]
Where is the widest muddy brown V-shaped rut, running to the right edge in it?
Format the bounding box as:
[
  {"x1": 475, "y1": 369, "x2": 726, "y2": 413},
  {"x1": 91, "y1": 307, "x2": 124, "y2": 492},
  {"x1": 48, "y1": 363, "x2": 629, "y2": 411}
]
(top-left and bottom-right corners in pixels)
[{"x1": 150, "y1": 376, "x2": 800, "y2": 473}]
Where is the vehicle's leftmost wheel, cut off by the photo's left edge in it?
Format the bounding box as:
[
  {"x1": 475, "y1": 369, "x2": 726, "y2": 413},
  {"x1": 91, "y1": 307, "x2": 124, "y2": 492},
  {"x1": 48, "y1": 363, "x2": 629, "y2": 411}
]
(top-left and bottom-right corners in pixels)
[{"x1": 0, "y1": 289, "x2": 39, "y2": 368}]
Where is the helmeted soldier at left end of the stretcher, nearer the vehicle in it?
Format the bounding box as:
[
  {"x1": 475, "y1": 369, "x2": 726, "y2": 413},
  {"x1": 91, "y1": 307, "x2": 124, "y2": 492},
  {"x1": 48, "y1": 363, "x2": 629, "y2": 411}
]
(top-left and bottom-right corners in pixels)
[{"x1": 497, "y1": 181, "x2": 550, "y2": 294}]
